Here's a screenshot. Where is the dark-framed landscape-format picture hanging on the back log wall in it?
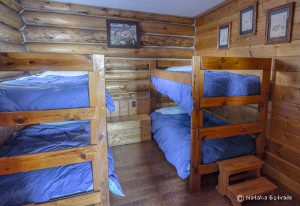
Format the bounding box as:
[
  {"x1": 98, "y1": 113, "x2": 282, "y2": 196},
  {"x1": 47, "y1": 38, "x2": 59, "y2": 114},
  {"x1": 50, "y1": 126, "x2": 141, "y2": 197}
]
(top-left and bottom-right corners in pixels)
[{"x1": 106, "y1": 19, "x2": 140, "y2": 48}]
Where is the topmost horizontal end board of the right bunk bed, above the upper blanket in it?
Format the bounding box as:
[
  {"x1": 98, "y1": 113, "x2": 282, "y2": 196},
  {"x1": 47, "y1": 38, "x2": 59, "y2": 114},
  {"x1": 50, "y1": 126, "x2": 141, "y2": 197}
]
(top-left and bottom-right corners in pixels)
[{"x1": 201, "y1": 57, "x2": 272, "y2": 70}]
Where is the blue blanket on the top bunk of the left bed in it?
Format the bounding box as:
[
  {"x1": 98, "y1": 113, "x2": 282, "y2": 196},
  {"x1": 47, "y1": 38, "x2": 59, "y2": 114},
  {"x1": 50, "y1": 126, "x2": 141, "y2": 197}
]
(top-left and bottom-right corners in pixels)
[{"x1": 0, "y1": 75, "x2": 115, "y2": 112}]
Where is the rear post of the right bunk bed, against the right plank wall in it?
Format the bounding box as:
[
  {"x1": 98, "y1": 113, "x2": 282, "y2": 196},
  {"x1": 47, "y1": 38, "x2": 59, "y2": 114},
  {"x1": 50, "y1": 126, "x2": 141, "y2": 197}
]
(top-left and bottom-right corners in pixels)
[{"x1": 255, "y1": 59, "x2": 275, "y2": 158}]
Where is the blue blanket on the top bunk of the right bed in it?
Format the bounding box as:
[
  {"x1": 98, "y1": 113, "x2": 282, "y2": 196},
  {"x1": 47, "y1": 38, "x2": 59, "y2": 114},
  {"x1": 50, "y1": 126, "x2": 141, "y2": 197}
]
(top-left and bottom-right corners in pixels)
[{"x1": 151, "y1": 70, "x2": 260, "y2": 115}]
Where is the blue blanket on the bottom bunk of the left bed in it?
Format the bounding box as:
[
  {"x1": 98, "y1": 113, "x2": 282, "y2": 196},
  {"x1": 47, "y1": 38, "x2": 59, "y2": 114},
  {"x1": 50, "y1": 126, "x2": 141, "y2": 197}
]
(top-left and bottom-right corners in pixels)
[{"x1": 0, "y1": 121, "x2": 123, "y2": 206}]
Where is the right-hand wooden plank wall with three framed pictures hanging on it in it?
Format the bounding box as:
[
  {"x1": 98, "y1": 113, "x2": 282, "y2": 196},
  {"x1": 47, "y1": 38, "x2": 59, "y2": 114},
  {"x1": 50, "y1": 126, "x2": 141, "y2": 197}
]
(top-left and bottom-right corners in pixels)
[{"x1": 195, "y1": 0, "x2": 300, "y2": 196}]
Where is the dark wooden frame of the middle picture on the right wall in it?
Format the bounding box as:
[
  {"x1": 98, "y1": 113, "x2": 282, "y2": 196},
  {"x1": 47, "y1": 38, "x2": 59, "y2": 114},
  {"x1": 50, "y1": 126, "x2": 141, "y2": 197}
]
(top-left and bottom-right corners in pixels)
[{"x1": 239, "y1": 1, "x2": 258, "y2": 37}]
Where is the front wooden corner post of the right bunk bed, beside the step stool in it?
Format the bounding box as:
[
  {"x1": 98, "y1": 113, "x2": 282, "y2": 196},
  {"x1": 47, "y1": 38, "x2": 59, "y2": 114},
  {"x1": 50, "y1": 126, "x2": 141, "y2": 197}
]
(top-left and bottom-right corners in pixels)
[{"x1": 189, "y1": 56, "x2": 204, "y2": 192}]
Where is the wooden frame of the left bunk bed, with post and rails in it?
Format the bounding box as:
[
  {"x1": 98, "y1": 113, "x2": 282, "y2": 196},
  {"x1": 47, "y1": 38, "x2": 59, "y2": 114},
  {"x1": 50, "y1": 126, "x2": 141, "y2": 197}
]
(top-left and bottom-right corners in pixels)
[{"x1": 0, "y1": 53, "x2": 109, "y2": 206}]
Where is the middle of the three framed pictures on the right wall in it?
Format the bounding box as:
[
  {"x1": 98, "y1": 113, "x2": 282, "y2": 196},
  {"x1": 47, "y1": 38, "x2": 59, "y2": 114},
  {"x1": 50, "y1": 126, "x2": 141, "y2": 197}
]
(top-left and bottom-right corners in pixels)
[{"x1": 239, "y1": 2, "x2": 257, "y2": 36}]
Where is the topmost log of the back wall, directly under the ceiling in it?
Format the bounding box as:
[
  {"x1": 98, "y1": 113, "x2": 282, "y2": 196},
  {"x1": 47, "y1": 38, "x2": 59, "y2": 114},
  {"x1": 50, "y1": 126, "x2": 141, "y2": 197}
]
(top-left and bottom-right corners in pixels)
[{"x1": 21, "y1": 0, "x2": 194, "y2": 25}]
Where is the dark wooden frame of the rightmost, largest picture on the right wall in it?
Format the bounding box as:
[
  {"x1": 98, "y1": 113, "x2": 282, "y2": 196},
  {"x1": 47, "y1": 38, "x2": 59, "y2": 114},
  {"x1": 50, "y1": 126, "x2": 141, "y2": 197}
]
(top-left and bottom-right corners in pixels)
[{"x1": 265, "y1": 2, "x2": 295, "y2": 44}]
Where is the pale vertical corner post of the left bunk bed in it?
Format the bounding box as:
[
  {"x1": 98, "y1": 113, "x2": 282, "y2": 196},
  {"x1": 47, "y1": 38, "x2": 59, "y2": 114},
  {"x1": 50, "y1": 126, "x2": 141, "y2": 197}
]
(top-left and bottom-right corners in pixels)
[{"x1": 89, "y1": 55, "x2": 109, "y2": 205}]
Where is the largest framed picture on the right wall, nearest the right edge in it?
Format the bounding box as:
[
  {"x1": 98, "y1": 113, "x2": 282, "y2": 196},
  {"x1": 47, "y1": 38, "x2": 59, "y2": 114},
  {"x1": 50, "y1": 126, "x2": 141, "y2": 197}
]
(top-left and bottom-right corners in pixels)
[{"x1": 266, "y1": 2, "x2": 295, "y2": 44}]
